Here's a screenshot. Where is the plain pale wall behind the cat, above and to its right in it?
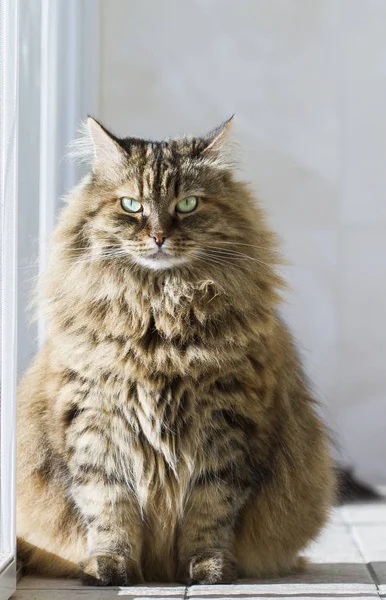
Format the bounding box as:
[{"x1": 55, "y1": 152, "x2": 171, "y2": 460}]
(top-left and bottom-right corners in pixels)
[{"x1": 99, "y1": 0, "x2": 386, "y2": 482}]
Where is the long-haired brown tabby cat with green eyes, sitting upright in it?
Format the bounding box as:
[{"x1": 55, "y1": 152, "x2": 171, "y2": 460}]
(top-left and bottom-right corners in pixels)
[{"x1": 18, "y1": 119, "x2": 334, "y2": 585}]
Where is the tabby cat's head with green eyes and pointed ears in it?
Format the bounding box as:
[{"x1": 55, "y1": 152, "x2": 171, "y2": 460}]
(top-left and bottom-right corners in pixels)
[{"x1": 65, "y1": 118, "x2": 260, "y2": 271}]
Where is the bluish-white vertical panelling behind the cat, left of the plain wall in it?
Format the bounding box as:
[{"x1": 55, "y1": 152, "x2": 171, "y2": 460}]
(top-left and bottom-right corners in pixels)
[{"x1": 18, "y1": 0, "x2": 99, "y2": 375}]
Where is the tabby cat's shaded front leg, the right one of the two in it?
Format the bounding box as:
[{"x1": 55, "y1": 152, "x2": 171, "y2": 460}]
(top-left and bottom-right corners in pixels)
[{"x1": 178, "y1": 479, "x2": 250, "y2": 584}]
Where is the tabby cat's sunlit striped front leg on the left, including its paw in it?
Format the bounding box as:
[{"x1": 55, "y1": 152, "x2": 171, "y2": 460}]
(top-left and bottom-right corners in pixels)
[{"x1": 66, "y1": 426, "x2": 143, "y2": 585}]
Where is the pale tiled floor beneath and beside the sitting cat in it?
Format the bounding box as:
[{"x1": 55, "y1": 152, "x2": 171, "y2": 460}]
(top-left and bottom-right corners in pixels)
[{"x1": 12, "y1": 500, "x2": 386, "y2": 600}]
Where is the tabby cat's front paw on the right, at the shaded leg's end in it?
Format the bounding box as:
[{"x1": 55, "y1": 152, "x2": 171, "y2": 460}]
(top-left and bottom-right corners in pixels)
[{"x1": 181, "y1": 550, "x2": 237, "y2": 585}]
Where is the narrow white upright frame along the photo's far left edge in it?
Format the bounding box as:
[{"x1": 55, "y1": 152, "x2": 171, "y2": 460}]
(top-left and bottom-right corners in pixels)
[{"x1": 0, "y1": 0, "x2": 18, "y2": 600}]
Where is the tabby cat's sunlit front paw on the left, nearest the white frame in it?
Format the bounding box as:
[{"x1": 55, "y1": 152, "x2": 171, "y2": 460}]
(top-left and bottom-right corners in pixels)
[{"x1": 80, "y1": 554, "x2": 143, "y2": 586}]
